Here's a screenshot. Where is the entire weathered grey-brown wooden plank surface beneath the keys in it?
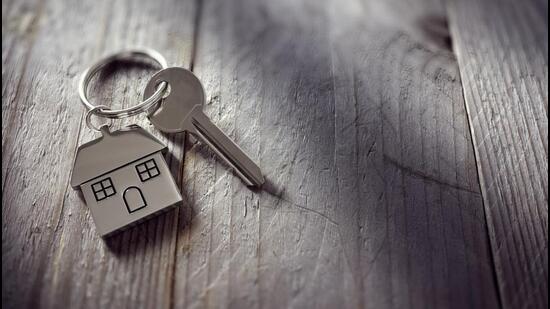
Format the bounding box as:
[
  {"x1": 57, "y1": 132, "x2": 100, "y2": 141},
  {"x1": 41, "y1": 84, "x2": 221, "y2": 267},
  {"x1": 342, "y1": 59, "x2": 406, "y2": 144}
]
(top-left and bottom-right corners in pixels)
[{"x1": 2, "y1": 0, "x2": 548, "y2": 308}]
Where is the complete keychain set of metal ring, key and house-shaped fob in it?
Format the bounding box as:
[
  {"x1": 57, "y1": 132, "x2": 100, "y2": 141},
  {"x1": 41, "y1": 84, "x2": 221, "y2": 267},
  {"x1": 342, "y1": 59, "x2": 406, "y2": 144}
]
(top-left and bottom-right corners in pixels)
[{"x1": 71, "y1": 49, "x2": 264, "y2": 237}]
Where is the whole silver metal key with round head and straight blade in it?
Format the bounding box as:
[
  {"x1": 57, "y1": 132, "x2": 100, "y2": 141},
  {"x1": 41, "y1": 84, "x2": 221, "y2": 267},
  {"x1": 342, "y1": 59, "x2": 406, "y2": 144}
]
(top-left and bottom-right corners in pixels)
[{"x1": 144, "y1": 67, "x2": 264, "y2": 187}]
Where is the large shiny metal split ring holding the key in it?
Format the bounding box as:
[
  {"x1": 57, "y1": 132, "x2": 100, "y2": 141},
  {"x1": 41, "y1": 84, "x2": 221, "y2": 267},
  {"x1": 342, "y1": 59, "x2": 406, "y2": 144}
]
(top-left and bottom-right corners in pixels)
[{"x1": 78, "y1": 48, "x2": 168, "y2": 119}]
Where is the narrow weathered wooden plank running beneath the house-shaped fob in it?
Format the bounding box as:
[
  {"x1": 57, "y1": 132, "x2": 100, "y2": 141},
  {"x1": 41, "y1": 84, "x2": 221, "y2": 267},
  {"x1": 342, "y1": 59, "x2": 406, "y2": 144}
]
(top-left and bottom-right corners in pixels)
[{"x1": 39, "y1": 1, "x2": 195, "y2": 308}]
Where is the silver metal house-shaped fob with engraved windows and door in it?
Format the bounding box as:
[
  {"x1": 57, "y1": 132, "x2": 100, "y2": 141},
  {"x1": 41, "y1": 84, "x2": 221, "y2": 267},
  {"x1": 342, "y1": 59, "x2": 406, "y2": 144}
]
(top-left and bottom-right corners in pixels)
[{"x1": 71, "y1": 125, "x2": 182, "y2": 236}]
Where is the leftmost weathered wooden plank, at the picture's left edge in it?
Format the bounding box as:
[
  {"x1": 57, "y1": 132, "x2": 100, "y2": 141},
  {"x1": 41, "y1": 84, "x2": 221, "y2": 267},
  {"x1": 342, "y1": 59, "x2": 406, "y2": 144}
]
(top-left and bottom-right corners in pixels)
[{"x1": 2, "y1": 1, "x2": 112, "y2": 307}]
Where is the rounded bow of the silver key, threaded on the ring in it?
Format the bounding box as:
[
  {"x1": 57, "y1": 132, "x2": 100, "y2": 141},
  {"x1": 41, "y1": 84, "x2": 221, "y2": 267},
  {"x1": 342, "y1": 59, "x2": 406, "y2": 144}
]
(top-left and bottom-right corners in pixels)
[{"x1": 143, "y1": 67, "x2": 205, "y2": 133}]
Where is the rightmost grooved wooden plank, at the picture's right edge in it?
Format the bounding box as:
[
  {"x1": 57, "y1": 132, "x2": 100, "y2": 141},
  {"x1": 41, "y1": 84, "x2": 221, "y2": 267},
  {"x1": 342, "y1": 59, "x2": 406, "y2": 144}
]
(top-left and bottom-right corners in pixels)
[{"x1": 449, "y1": 0, "x2": 548, "y2": 308}]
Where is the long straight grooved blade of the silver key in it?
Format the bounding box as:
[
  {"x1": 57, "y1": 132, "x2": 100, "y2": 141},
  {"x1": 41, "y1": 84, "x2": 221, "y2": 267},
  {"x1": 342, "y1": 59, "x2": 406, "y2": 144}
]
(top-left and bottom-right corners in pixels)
[{"x1": 188, "y1": 109, "x2": 265, "y2": 187}]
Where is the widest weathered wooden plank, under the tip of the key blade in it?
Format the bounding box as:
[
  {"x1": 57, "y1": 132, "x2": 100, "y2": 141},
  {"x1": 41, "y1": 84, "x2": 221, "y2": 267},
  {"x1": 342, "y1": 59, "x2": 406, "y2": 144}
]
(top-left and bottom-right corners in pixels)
[{"x1": 179, "y1": 0, "x2": 498, "y2": 308}]
